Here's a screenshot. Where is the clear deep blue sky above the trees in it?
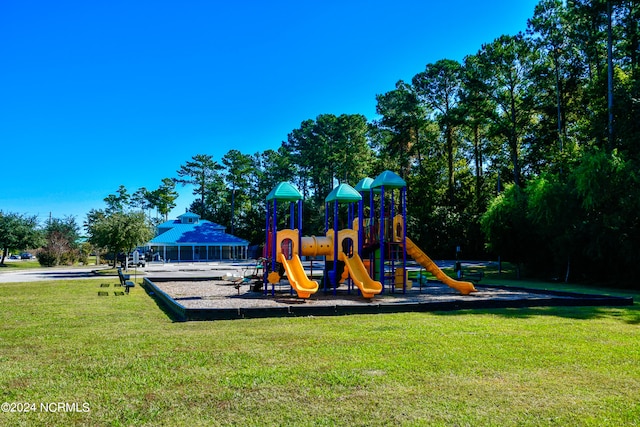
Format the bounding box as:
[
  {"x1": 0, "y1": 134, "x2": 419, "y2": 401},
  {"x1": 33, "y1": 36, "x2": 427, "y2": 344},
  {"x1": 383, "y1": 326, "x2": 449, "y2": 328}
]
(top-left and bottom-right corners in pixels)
[{"x1": 0, "y1": 0, "x2": 537, "y2": 224}]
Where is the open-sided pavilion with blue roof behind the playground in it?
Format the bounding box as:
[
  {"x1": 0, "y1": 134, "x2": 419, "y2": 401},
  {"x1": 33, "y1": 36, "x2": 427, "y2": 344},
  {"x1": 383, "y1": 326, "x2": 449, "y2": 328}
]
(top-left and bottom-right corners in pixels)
[{"x1": 146, "y1": 212, "x2": 249, "y2": 262}]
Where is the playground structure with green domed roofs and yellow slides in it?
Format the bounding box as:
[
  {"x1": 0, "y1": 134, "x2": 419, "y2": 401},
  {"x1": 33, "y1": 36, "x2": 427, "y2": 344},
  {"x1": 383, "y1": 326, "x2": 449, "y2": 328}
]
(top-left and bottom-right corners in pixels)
[{"x1": 263, "y1": 171, "x2": 476, "y2": 299}]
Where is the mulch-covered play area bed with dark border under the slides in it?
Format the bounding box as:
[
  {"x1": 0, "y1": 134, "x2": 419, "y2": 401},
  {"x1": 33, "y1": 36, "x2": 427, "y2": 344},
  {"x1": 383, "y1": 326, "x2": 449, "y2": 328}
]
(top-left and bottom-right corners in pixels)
[{"x1": 144, "y1": 277, "x2": 633, "y2": 321}]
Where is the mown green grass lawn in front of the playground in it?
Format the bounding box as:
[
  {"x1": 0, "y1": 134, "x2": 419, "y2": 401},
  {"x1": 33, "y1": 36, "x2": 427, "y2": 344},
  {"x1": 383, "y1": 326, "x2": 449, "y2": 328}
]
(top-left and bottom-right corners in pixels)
[{"x1": 0, "y1": 277, "x2": 640, "y2": 427}]
